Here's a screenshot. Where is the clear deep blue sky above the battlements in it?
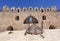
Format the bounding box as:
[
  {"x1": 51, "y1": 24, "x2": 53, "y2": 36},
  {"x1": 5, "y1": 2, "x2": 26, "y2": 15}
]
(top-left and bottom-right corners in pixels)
[{"x1": 0, "y1": 0, "x2": 60, "y2": 10}]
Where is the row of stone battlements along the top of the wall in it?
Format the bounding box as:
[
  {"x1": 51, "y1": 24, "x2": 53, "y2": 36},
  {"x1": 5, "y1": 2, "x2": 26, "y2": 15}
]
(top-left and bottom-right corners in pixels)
[{"x1": 3, "y1": 6, "x2": 56, "y2": 12}]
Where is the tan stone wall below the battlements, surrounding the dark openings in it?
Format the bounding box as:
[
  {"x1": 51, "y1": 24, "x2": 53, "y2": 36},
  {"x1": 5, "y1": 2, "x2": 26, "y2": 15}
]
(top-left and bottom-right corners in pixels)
[{"x1": 0, "y1": 5, "x2": 60, "y2": 31}]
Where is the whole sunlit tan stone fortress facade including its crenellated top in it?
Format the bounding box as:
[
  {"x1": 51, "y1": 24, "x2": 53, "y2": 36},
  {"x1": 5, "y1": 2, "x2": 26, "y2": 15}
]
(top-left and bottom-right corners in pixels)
[{"x1": 0, "y1": 6, "x2": 60, "y2": 31}]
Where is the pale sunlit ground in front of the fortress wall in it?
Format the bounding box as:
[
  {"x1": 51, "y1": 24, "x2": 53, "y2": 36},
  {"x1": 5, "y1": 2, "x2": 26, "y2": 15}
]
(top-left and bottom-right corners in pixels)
[{"x1": 0, "y1": 29, "x2": 60, "y2": 41}]
